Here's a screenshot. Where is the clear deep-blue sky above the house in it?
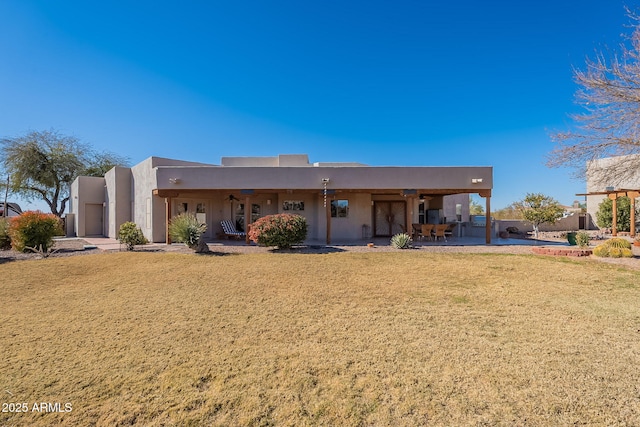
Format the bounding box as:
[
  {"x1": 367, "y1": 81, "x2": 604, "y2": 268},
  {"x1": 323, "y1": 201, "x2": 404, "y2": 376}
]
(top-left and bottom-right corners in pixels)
[{"x1": 0, "y1": 0, "x2": 637, "y2": 208}]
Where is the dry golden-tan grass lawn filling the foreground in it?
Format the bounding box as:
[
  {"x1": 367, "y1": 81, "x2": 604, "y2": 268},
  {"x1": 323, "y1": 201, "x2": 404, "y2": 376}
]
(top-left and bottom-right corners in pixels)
[{"x1": 0, "y1": 251, "x2": 640, "y2": 426}]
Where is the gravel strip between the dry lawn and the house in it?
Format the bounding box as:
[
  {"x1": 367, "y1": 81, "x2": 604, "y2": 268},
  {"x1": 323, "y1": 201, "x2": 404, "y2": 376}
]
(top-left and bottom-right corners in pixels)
[{"x1": 0, "y1": 237, "x2": 640, "y2": 270}]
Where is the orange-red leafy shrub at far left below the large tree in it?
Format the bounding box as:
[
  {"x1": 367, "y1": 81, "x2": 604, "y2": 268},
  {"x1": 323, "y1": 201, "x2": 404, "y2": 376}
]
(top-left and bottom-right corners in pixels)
[{"x1": 9, "y1": 211, "x2": 62, "y2": 252}]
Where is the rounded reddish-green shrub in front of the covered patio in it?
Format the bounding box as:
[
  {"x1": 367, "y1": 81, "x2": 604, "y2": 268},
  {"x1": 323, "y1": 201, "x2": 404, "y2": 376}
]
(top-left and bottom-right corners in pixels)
[{"x1": 249, "y1": 214, "x2": 308, "y2": 249}]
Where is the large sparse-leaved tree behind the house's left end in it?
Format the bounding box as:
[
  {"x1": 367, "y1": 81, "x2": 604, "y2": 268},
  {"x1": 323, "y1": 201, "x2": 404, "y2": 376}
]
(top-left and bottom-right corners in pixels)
[{"x1": 0, "y1": 130, "x2": 127, "y2": 217}]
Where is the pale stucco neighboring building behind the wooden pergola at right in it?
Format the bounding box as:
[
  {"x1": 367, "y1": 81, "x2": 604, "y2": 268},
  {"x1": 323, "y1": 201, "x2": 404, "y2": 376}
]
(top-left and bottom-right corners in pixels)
[{"x1": 587, "y1": 155, "x2": 640, "y2": 227}]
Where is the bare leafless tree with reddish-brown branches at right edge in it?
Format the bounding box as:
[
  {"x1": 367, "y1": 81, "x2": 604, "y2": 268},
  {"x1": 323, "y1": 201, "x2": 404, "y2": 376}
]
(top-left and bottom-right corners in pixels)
[{"x1": 547, "y1": 9, "x2": 640, "y2": 185}]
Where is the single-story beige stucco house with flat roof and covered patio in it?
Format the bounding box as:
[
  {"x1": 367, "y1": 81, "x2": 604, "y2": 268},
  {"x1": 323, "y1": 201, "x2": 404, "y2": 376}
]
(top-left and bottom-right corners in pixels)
[{"x1": 70, "y1": 154, "x2": 493, "y2": 243}]
